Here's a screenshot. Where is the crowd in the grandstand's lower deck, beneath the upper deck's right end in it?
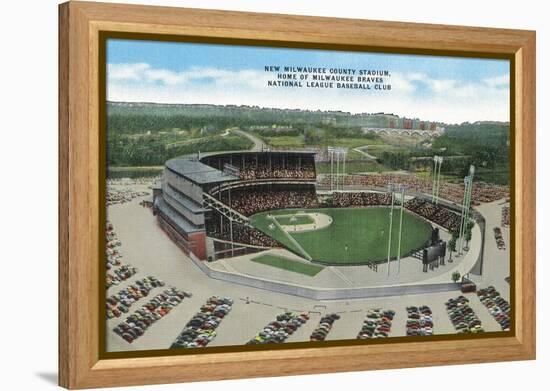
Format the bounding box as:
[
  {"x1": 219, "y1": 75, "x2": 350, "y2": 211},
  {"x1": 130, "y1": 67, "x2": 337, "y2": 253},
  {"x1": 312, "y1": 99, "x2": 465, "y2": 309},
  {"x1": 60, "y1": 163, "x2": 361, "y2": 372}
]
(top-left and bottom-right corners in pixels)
[{"x1": 222, "y1": 186, "x2": 318, "y2": 216}]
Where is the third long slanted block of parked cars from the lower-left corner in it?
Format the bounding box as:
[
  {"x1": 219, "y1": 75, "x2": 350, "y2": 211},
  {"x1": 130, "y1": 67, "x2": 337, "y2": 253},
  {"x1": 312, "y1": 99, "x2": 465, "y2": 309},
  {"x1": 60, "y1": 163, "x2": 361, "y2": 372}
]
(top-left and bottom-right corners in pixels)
[{"x1": 170, "y1": 296, "x2": 233, "y2": 349}]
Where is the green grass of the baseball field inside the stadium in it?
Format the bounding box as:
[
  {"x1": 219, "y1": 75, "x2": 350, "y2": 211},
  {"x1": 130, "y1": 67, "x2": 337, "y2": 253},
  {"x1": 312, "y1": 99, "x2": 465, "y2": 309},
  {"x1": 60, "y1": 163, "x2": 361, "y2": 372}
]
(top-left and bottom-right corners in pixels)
[{"x1": 250, "y1": 207, "x2": 431, "y2": 265}]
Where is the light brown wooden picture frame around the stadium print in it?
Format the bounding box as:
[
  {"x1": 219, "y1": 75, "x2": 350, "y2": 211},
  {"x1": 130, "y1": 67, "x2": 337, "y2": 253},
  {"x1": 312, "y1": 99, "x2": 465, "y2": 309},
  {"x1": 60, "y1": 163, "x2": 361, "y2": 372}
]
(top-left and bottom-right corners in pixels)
[{"x1": 59, "y1": 1, "x2": 536, "y2": 389}]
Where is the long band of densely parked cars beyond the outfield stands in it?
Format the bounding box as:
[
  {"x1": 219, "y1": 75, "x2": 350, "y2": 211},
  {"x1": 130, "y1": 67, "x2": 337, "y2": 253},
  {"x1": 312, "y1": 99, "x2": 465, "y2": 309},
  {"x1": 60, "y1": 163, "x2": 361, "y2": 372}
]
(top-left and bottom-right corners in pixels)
[{"x1": 321, "y1": 174, "x2": 510, "y2": 205}]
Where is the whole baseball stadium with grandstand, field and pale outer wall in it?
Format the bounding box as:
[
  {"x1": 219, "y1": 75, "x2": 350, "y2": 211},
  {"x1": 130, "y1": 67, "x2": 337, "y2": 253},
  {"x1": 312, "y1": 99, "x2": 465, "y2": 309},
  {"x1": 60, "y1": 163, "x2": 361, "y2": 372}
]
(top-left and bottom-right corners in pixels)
[{"x1": 153, "y1": 149, "x2": 483, "y2": 298}]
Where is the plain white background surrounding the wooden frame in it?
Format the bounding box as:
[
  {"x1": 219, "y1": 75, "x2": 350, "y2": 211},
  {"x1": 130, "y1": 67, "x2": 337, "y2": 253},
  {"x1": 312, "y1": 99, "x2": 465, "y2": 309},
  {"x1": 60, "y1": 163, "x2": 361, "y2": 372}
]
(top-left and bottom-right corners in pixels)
[{"x1": 0, "y1": 0, "x2": 550, "y2": 391}]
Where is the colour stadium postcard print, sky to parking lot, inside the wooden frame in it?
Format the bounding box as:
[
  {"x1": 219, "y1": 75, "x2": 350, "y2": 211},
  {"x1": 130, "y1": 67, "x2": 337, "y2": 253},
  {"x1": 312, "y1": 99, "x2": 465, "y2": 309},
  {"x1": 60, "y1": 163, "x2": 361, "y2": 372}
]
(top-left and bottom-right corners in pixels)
[{"x1": 101, "y1": 39, "x2": 514, "y2": 356}]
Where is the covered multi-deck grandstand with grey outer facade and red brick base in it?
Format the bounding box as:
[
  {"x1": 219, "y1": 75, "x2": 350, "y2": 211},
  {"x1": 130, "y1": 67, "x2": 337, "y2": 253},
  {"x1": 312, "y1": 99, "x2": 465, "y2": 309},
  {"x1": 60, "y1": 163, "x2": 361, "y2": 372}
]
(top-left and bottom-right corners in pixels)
[{"x1": 153, "y1": 151, "x2": 317, "y2": 260}]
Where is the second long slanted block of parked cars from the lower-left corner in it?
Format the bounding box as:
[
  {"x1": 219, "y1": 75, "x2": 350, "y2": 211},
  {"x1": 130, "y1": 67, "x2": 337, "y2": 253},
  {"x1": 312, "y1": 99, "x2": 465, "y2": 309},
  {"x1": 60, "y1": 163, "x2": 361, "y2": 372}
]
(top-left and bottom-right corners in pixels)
[{"x1": 113, "y1": 288, "x2": 191, "y2": 343}]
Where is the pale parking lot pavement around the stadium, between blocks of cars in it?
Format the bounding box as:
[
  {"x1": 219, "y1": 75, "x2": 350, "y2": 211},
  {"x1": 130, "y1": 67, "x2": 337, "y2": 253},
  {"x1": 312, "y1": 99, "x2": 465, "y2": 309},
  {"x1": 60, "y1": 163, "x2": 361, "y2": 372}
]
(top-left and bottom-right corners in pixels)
[{"x1": 106, "y1": 186, "x2": 509, "y2": 351}]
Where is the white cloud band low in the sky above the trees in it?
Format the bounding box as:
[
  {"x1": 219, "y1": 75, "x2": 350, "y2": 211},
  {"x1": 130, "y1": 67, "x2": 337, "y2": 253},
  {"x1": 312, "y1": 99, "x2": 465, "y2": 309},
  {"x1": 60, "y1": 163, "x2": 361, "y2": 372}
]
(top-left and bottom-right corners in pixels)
[{"x1": 107, "y1": 63, "x2": 509, "y2": 123}]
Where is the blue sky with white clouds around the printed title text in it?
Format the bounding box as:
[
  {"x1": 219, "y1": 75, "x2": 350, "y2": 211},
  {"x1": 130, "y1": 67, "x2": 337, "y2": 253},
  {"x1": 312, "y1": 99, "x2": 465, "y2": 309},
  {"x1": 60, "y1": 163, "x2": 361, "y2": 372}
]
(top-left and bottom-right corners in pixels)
[{"x1": 107, "y1": 40, "x2": 509, "y2": 123}]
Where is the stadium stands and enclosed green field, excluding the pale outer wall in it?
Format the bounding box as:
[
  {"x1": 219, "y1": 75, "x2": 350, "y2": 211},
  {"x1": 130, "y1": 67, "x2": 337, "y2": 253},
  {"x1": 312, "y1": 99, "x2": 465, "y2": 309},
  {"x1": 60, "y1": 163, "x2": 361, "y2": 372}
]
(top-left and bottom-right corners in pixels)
[{"x1": 153, "y1": 150, "x2": 484, "y2": 278}]
